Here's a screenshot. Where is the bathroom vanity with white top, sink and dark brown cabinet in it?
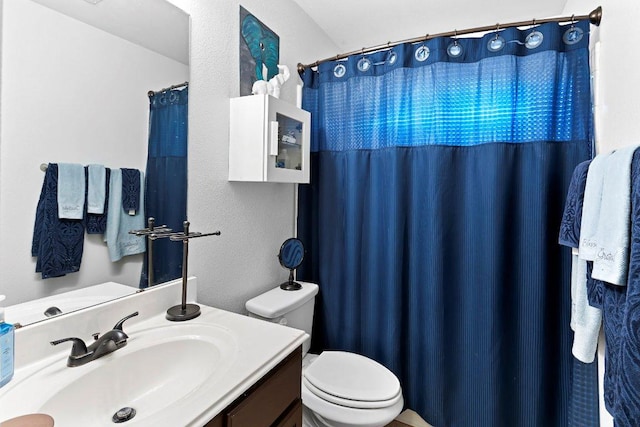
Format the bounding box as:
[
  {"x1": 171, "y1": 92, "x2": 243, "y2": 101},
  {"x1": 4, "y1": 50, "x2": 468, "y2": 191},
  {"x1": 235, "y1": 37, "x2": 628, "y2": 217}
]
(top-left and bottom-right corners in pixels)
[{"x1": 0, "y1": 278, "x2": 308, "y2": 427}]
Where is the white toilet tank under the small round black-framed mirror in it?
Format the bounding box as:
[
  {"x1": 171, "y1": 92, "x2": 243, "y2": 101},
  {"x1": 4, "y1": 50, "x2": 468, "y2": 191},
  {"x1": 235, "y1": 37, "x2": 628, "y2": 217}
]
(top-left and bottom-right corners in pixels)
[{"x1": 245, "y1": 281, "x2": 318, "y2": 356}]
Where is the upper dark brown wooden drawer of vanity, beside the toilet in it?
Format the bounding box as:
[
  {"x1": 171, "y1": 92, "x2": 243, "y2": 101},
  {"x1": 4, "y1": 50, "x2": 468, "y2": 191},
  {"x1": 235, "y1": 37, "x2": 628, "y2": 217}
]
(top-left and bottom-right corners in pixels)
[{"x1": 226, "y1": 350, "x2": 302, "y2": 427}]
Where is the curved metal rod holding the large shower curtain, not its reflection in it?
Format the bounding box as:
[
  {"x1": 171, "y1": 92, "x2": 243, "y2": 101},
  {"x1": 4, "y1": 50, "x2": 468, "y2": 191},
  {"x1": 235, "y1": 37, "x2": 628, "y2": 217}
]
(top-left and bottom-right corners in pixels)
[{"x1": 298, "y1": 6, "x2": 602, "y2": 73}]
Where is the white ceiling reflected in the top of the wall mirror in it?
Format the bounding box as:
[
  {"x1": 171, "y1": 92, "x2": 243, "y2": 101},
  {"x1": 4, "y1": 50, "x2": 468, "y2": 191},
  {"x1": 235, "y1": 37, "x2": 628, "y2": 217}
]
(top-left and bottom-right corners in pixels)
[{"x1": 33, "y1": 0, "x2": 189, "y2": 64}]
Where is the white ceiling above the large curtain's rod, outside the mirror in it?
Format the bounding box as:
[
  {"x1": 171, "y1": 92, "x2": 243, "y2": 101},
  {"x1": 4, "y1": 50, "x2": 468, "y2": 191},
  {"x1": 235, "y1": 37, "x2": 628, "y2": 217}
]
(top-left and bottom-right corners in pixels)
[{"x1": 293, "y1": 0, "x2": 568, "y2": 54}]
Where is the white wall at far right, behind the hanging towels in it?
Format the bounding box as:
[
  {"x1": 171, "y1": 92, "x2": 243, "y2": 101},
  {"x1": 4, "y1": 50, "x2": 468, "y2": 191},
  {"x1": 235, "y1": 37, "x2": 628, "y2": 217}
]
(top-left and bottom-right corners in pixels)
[{"x1": 563, "y1": 0, "x2": 640, "y2": 427}]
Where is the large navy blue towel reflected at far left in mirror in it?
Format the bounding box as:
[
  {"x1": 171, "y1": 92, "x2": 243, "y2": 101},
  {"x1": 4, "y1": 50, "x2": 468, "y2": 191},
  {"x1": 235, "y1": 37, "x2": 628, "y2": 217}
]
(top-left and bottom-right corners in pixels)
[{"x1": 31, "y1": 163, "x2": 84, "y2": 279}]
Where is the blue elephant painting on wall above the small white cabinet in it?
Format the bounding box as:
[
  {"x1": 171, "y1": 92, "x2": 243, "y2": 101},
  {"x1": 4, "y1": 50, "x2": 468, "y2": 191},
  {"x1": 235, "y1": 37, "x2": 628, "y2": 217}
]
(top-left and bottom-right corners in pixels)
[{"x1": 240, "y1": 6, "x2": 280, "y2": 96}]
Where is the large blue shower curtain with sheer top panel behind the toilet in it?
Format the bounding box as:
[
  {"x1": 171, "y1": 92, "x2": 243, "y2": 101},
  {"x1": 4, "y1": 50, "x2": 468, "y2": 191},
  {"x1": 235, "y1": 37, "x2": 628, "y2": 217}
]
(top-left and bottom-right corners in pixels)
[{"x1": 298, "y1": 21, "x2": 598, "y2": 427}]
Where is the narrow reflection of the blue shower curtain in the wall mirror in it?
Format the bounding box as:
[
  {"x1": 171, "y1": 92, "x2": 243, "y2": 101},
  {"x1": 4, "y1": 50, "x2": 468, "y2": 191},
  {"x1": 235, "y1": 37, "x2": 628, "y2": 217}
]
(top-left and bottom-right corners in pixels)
[{"x1": 140, "y1": 88, "x2": 189, "y2": 288}]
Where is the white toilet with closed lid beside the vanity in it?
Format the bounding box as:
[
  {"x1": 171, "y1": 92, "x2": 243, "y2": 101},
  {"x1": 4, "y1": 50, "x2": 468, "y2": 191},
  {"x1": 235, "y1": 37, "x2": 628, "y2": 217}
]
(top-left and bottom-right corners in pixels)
[{"x1": 246, "y1": 282, "x2": 404, "y2": 427}]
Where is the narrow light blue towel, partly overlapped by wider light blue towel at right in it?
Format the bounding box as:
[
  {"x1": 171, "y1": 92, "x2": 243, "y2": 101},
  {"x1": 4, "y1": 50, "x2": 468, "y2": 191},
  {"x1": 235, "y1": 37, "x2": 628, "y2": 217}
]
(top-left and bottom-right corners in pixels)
[{"x1": 578, "y1": 153, "x2": 609, "y2": 261}]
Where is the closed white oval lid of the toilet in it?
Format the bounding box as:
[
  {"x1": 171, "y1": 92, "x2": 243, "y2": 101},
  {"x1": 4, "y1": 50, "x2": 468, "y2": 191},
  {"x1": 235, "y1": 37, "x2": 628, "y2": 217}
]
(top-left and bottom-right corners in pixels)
[{"x1": 303, "y1": 351, "x2": 402, "y2": 408}]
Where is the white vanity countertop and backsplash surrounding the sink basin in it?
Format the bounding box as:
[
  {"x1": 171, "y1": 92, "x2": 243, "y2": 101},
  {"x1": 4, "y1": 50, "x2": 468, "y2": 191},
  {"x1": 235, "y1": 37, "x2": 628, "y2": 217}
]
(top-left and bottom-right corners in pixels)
[{"x1": 0, "y1": 279, "x2": 309, "y2": 427}]
